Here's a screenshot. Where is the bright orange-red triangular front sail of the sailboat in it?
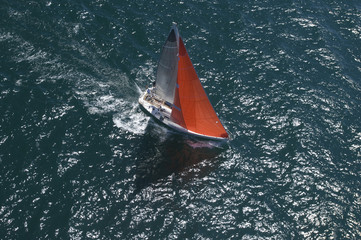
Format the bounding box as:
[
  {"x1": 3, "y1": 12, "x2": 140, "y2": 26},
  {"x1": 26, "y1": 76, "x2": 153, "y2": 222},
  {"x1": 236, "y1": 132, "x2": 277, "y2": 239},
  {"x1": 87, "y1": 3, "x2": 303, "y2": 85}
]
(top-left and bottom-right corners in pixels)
[{"x1": 171, "y1": 37, "x2": 228, "y2": 138}]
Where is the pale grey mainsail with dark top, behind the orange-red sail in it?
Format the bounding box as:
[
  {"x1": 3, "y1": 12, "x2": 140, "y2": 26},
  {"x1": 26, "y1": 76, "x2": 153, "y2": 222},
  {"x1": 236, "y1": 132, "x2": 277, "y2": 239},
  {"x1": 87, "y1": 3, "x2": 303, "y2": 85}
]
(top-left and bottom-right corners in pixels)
[{"x1": 155, "y1": 25, "x2": 179, "y2": 103}]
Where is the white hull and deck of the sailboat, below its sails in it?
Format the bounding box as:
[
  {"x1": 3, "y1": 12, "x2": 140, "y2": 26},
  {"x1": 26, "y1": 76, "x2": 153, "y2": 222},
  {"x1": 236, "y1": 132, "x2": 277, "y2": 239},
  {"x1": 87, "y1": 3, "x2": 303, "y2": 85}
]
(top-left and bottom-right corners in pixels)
[{"x1": 138, "y1": 88, "x2": 227, "y2": 141}]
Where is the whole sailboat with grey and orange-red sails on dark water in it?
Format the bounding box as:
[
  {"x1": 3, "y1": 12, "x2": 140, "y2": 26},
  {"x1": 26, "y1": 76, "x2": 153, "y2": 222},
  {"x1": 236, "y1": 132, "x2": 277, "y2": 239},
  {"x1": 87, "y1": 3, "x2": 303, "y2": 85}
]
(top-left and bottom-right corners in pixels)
[{"x1": 139, "y1": 24, "x2": 228, "y2": 140}]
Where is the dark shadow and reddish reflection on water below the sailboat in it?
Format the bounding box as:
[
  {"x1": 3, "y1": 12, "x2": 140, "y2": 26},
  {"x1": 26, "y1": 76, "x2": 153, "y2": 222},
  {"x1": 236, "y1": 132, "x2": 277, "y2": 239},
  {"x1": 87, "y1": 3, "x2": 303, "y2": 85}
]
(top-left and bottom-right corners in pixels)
[{"x1": 135, "y1": 119, "x2": 227, "y2": 192}]
